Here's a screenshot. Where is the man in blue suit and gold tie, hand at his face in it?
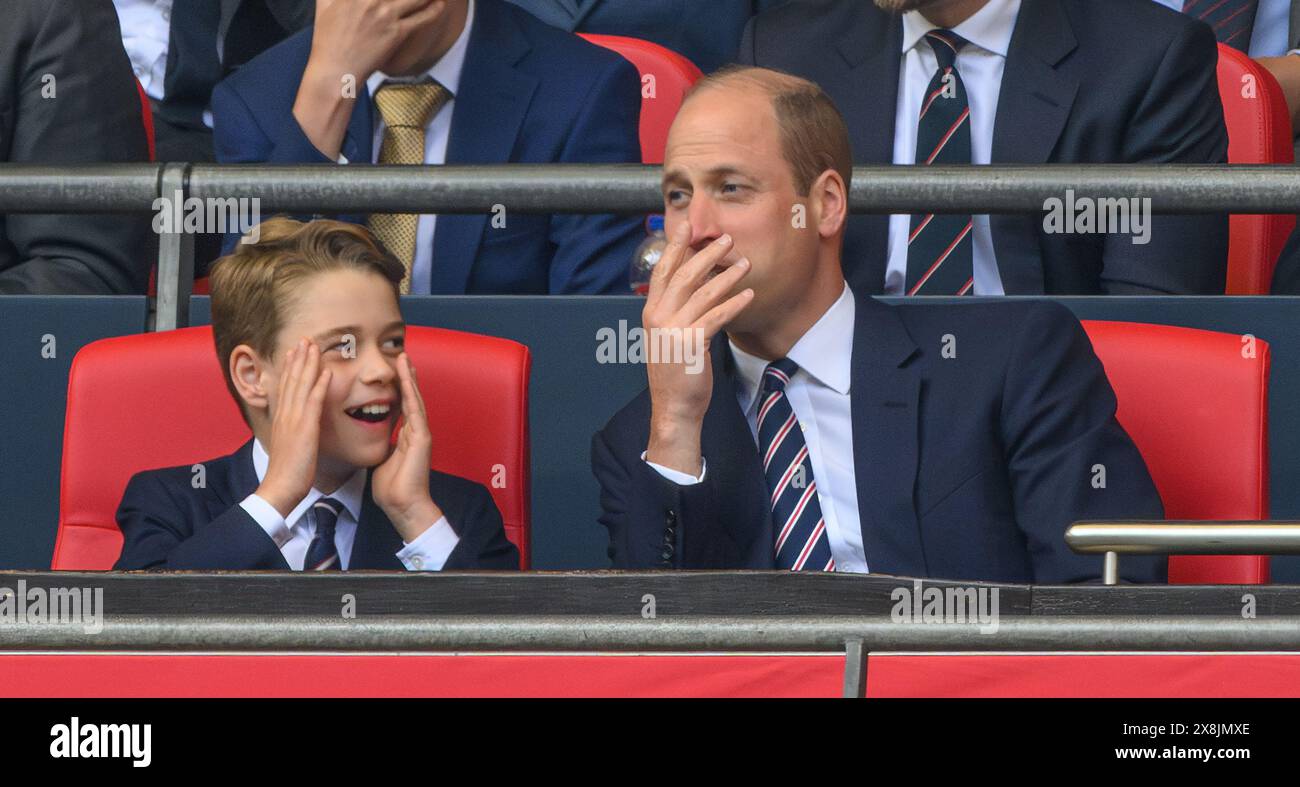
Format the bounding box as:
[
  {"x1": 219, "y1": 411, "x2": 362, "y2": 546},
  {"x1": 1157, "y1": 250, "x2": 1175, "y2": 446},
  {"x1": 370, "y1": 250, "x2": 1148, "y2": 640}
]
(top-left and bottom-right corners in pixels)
[{"x1": 212, "y1": 0, "x2": 645, "y2": 294}]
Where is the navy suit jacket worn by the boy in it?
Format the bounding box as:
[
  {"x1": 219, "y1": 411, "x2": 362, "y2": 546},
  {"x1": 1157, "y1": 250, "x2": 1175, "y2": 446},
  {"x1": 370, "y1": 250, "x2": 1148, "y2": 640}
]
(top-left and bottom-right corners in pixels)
[{"x1": 113, "y1": 440, "x2": 519, "y2": 571}]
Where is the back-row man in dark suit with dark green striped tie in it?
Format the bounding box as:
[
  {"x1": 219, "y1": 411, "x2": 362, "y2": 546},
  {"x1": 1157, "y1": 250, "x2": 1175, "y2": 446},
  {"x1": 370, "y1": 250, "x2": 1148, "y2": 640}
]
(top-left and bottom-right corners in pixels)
[{"x1": 737, "y1": 0, "x2": 1227, "y2": 295}]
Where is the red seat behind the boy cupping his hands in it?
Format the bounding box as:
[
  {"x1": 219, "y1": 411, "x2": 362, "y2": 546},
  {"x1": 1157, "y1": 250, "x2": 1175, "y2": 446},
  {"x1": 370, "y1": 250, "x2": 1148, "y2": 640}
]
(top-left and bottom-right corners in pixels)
[{"x1": 51, "y1": 325, "x2": 532, "y2": 571}]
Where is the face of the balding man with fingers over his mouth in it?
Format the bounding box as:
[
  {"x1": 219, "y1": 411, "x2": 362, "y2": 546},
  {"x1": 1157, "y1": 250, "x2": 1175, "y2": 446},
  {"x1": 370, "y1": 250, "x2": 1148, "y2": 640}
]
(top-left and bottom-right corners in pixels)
[{"x1": 663, "y1": 86, "x2": 818, "y2": 332}]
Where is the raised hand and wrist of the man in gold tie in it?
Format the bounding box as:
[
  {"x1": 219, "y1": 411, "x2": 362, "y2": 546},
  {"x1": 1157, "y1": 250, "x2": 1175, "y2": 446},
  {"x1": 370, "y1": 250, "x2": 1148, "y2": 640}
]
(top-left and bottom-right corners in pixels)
[{"x1": 294, "y1": 0, "x2": 447, "y2": 164}]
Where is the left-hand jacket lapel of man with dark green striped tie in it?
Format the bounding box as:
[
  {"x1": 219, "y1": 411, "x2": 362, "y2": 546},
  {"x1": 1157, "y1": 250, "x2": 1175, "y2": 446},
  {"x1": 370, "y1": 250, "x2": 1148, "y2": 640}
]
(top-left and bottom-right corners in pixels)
[{"x1": 836, "y1": 3, "x2": 902, "y2": 286}]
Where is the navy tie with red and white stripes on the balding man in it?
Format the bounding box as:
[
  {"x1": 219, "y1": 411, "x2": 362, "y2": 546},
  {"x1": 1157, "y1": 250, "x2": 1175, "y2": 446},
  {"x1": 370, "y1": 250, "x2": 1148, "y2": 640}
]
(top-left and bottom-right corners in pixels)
[{"x1": 758, "y1": 358, "x2": 835, "y2": 571}]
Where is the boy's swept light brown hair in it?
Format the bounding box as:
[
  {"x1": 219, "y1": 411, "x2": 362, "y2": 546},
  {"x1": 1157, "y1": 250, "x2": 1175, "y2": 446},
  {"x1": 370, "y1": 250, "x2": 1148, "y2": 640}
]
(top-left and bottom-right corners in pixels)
[{"x1": 208, "y1": 216, "x2": 406, "y2": 425}]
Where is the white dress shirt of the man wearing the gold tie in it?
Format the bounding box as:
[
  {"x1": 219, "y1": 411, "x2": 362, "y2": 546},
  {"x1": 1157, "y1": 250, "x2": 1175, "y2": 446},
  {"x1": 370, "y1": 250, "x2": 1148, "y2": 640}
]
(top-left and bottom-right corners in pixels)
[{"x1": 339, "y1": 0, "x2": 475, "y2": 295}]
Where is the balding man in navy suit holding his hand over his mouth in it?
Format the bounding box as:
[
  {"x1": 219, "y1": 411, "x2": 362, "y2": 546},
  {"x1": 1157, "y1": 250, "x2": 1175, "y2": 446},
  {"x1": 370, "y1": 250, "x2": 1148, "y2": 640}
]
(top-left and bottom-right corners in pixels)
[{"x1": 592, "y1": 69, "x2": 1165, "y2": 583}]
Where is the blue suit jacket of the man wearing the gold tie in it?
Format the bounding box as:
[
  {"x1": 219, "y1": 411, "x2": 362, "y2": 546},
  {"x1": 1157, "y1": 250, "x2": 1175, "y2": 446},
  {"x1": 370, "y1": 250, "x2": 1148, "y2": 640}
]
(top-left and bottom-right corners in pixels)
[{"x1": 212, "y1": 0, "x2": 645, "y2": 295}]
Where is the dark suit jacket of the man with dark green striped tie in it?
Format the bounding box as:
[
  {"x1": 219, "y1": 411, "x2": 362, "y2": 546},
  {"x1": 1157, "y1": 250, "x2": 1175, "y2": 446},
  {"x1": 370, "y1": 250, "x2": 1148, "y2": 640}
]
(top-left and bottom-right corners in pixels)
[{"x1": 738, "y1": 0, "x2": 1227, "y2": 295}]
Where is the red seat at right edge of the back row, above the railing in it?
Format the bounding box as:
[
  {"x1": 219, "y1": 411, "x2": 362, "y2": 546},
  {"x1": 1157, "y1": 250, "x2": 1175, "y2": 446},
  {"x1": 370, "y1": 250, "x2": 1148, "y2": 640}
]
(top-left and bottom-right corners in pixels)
[{"x1": 1218, "y1": 44, "x2": 1296, "y2": 295}]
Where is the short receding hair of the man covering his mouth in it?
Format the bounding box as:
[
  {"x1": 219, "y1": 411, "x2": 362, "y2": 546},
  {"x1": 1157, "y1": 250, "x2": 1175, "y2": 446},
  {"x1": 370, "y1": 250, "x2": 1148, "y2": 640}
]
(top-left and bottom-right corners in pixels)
[{"x1": 683, "y1": 65, "x2": 853, "y2": 195}]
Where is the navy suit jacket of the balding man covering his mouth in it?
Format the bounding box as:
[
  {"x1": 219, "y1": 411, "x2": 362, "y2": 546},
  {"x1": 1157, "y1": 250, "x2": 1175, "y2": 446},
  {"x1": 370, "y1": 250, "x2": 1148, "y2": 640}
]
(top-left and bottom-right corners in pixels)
[{"x1": 592, "y1": 297, "x2": 1165, "y2": 583}]
